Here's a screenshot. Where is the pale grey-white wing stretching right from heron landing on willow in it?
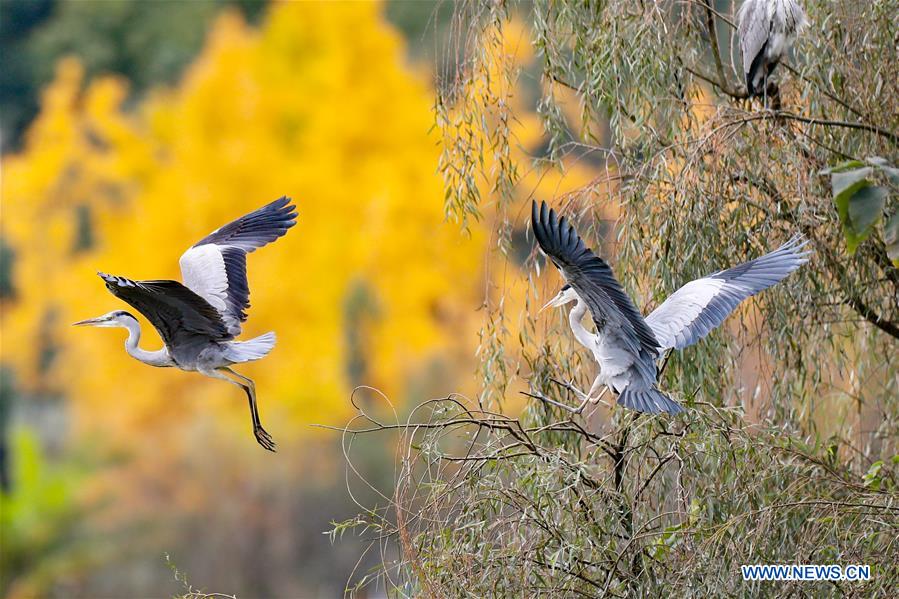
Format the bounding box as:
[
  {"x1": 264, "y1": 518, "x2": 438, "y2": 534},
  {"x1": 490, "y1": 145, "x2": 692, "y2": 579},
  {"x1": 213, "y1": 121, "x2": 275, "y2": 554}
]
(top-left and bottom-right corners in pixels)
[{"x1": 646, "y1": 236, "x2": 811, "y2": 349}]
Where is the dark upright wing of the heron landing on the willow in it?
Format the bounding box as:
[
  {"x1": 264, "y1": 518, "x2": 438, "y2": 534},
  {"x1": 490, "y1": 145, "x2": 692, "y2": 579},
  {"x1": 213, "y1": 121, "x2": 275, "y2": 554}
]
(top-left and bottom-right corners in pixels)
[{"x1": 531, "y1": 202, "x2": 659, "y2": 356}]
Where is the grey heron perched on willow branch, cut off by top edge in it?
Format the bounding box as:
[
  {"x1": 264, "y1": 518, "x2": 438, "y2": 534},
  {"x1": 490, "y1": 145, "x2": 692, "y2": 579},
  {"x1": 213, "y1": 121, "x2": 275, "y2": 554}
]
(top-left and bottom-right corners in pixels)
[{"x1": 737, "y1": 0, "x2": 808, "y2": 96}]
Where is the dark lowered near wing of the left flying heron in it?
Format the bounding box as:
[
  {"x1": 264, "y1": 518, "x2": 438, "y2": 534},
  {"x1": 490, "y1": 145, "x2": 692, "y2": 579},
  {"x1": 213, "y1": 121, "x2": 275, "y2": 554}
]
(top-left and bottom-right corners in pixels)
[{"x1": 97, "y1": 272, "x2": 233, "y2": 350}]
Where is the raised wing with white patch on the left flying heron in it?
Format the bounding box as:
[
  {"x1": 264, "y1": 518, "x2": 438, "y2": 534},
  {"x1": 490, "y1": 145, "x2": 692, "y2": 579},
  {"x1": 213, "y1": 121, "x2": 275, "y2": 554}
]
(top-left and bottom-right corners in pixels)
[{"x1": 179, "y1": 197, "x2": 297, "y2": 336}]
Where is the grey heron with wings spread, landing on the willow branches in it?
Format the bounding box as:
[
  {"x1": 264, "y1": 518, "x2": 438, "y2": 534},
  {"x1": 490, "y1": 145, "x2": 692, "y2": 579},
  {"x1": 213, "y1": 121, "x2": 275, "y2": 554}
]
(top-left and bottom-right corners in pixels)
[{"x1": 531, "y1": 202, "x2": 809, "y2": 414}]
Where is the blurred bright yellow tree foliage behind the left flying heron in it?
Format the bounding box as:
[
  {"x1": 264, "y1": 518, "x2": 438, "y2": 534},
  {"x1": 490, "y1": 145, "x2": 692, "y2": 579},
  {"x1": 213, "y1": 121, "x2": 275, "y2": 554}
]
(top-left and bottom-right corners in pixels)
[{"x1": 3, "y1": 3, "x2": 492, "y2": 442}]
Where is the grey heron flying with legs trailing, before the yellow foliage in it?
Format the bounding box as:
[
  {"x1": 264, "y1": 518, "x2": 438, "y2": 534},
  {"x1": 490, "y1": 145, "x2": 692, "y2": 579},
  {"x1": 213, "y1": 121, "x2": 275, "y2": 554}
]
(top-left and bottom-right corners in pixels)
[{"x1": 75, "y1": 197, "x2": 297, "y2": 451}]
